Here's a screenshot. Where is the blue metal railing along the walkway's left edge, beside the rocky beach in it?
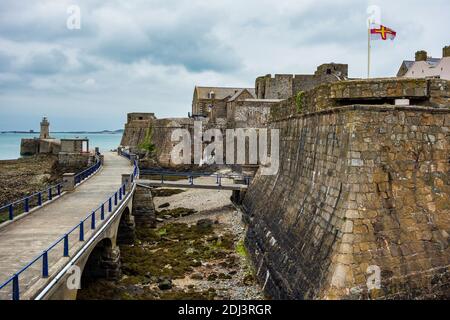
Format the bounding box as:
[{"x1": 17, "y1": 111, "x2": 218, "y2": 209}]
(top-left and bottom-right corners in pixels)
[{"x1": 0, "y1": 160, "x2": 101, "y2": 221}]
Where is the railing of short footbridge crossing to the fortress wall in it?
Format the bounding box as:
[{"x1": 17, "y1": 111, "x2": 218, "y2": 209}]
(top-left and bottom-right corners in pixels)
[{"x1": 140, "y1": 169, "x2": 252, "y2": 186}]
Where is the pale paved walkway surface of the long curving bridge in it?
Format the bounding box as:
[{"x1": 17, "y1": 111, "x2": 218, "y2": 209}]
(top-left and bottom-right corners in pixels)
[{"x1": 0, "y1": 152, "x2": 133, "y2": 299}]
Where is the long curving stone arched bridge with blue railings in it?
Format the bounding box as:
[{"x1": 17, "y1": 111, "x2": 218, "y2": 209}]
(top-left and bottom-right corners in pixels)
[{"x1": 0, "y1": 153, "x2": 139, "y2": 300}]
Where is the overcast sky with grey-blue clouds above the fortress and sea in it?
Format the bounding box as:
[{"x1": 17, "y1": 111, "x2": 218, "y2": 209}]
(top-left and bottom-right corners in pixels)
[{"x1": 0, "y1": 0, "x2": 450, "y2": 131}]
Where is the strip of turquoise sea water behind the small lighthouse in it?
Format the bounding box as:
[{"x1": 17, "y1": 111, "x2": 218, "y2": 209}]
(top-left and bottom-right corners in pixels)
[{"x1": 0, "y1": 133, "x2": 122, "y2": 160}]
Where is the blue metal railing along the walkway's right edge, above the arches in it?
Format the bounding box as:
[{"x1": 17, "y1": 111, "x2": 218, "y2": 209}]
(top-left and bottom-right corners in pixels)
[{"x1": 0, "y1": 162, "x2": 139, "y2": 300}]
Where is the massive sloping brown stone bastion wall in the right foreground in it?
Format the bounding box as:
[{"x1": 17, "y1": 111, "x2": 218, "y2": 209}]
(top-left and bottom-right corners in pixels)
[{"x1": 243, "y1": 106, "x2": 450, "y2": 299}]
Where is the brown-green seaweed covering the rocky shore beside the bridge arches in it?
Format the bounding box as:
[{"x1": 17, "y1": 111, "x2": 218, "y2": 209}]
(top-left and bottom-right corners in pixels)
[{"x1": 78, "y1": 223, "x2": 238, "y2": 300}]
